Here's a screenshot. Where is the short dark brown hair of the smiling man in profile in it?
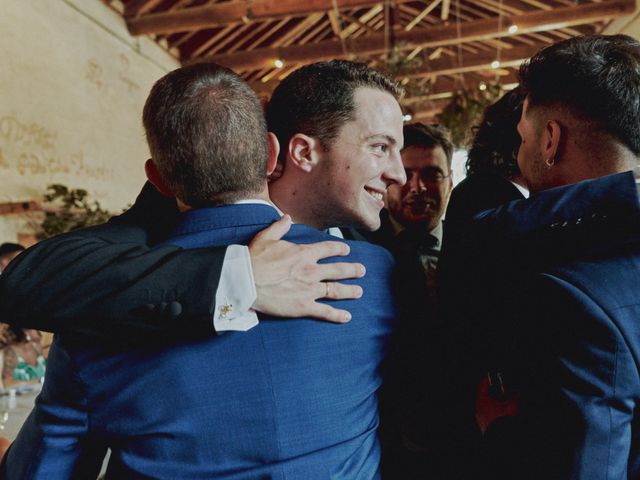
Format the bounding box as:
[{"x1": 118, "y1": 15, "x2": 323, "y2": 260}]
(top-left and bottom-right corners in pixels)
[{"x1": 267, "y1": 60, "x2": 402, "y2": 159}]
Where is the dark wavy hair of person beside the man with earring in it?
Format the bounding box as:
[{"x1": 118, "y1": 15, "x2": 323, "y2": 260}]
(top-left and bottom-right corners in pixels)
[{"x1": 467, "y1": 88, "x2": 524, "y2": 179}]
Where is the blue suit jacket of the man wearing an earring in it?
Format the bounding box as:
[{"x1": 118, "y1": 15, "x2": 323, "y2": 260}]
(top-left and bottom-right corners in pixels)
[{"x1": 442, "y1": 173, "x2": 640, "y2": 479}]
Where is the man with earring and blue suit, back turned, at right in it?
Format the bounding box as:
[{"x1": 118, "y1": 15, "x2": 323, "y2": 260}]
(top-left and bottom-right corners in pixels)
[{"x1": 442, "y1": 35, "x2": 640, "y2": 480}]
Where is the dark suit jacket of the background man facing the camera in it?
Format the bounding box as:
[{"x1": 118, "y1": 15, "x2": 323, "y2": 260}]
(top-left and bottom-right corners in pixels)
[{"x1": 365, "y1": 209, "x2": 453, "y2": 480}]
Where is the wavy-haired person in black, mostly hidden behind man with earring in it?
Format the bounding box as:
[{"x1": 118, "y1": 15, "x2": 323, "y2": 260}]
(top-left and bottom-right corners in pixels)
[{"x1": 438, "y1": 88, "x2": 528, "y2": 464}]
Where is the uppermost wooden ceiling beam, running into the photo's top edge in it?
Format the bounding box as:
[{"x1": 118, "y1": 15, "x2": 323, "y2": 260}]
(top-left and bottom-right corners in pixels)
[{"x1": 126, "y1": 0, "x2": 418, "y2": 35}]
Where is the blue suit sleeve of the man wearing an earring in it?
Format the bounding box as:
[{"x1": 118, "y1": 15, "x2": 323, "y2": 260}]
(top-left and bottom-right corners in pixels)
[{"x1": 491, "y1": 275, "x2": 640, "y2": 480}]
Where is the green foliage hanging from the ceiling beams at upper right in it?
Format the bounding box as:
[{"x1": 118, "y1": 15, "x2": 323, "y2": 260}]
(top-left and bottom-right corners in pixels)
[{"x1": 438, "y1": 83, "x2": 504, "y2": 148}]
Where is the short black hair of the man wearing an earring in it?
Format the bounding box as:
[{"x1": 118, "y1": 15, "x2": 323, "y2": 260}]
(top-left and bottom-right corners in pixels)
[{"x1": 520, "y1": 35, "x2": 640, "y2": 155}]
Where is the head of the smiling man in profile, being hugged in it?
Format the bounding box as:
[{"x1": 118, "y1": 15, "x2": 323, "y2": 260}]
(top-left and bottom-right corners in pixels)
[{"x1": 267, "y1": 60, "x2": 405, "y2": 230}]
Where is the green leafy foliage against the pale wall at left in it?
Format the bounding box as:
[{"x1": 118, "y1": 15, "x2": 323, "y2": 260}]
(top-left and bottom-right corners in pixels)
[{"x1": 38, "y1": 184, "x2": 112, "y2": 240}]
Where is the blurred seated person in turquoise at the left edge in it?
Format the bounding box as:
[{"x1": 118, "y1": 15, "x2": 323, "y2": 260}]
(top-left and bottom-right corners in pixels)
[{"x1": 2, "y1": 324, "x2": 47, "y2": 388}]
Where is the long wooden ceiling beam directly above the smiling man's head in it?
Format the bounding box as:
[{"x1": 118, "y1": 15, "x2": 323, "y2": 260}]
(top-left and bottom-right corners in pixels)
[{"x1": 206, "y1": 0, "x2": 635, "y2": 71}]
